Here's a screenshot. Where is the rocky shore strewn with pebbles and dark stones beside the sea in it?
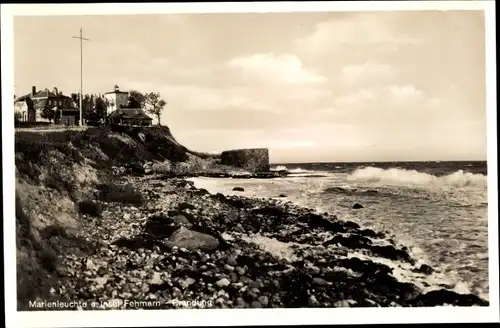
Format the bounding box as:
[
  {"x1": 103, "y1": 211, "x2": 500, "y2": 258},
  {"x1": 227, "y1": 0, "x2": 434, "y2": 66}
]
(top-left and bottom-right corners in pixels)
[{"x1": 38, "y1": 170, "x2": 488, "y2": 310}]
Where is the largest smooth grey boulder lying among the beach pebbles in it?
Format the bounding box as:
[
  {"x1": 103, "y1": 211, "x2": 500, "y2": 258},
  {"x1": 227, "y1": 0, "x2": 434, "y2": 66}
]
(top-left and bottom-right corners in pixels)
[{"x1": 164, "y1": 227, "x2": 219, "y2": 251}]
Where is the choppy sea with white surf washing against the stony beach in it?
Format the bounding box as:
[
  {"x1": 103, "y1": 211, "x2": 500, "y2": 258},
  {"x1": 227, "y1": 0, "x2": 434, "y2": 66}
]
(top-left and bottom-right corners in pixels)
[{"x1": 188, "y1": 161, "x2": 489, "y2": 299}]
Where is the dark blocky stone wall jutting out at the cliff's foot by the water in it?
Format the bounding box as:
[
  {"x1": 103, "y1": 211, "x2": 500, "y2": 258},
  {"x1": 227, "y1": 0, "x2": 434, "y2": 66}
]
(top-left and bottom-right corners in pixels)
[{"x1": 221, "y1": 148, "x2": 269, "y2": 172}]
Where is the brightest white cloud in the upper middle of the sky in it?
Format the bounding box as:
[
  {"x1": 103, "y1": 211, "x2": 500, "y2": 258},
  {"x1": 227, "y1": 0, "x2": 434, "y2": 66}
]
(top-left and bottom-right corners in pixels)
[{"x1": 228, "y1": 53, "x2": 326, "y2": 85}]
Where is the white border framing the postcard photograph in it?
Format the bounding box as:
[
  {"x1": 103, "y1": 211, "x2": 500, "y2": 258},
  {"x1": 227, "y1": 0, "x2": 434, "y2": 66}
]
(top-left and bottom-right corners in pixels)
[{"x1": 1, "y1": 1, "x2": 500, "y2": 327}]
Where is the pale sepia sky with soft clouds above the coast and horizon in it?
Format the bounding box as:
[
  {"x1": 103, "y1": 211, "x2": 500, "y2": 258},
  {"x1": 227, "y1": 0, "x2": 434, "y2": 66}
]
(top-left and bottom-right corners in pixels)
[{"x1": 14, "y1": 11, "x2": 486, "y2": 163}]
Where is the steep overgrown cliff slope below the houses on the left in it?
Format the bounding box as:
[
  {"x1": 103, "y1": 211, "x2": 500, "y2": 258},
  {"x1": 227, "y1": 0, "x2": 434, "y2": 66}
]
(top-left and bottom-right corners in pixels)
[{"x1": 15, "y1": 127, "x2": 217, "y2": 309}]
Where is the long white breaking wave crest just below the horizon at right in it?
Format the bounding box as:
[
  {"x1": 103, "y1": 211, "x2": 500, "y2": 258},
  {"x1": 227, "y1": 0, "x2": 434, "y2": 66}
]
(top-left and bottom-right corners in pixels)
[{"x1": 348, "y1": 167, "x2": 487, "y2": 188}]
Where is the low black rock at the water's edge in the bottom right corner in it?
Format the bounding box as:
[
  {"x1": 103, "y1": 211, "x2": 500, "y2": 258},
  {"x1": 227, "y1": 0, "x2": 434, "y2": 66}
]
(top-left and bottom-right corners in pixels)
[{"x1": 410, "y1": 289, "x2": 489, "y2": 306}]
